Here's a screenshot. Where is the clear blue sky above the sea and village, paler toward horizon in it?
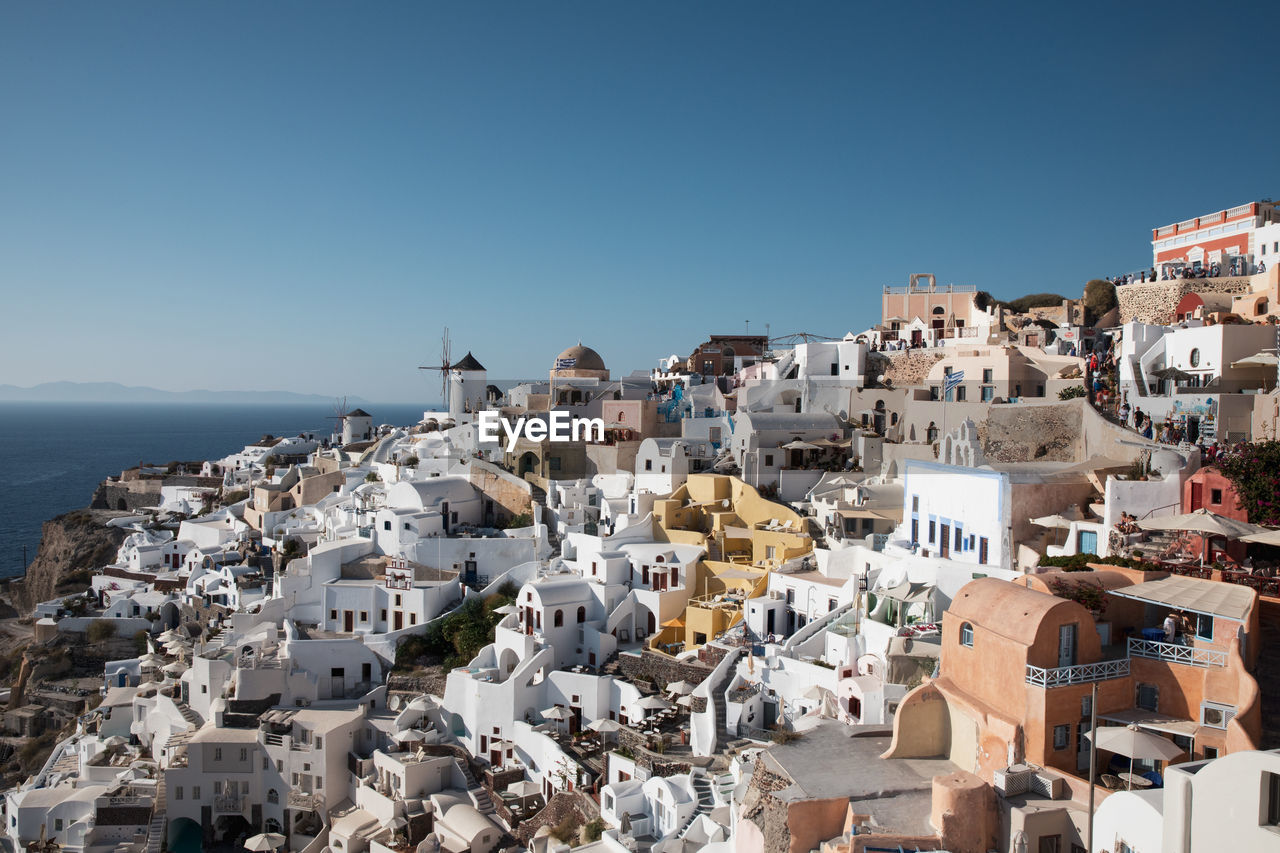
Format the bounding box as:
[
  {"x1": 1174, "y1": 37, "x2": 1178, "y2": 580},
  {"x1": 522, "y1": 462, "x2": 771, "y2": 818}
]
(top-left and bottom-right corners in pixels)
[{"x1": 0, "y1": 0, "x2": 1280, "y2": 401}]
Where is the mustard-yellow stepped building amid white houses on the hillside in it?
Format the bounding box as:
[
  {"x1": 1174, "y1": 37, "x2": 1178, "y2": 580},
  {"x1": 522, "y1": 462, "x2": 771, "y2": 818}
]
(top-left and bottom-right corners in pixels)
[{"x1": 650, "y1": 474, "x2": 813, "y2": 649}]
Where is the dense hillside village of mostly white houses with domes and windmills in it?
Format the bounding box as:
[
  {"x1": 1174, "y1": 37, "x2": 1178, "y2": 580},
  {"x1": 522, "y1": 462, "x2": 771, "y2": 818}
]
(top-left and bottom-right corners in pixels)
[{"x1": 0, "y1": 201, "x2": 1280, "y2": 853}]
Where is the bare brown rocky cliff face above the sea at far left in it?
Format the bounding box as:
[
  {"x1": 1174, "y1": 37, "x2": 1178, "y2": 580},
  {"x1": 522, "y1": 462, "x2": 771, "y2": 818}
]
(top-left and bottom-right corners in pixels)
[{"x1": 8, "y1": 510, "x2": 127, "y2": 616}]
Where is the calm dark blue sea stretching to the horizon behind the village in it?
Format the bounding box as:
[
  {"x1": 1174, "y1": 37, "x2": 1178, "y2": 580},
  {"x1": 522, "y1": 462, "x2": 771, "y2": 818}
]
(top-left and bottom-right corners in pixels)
[{"x1": 0, "y1": 403, "x2": 429, "y2": 578}]
